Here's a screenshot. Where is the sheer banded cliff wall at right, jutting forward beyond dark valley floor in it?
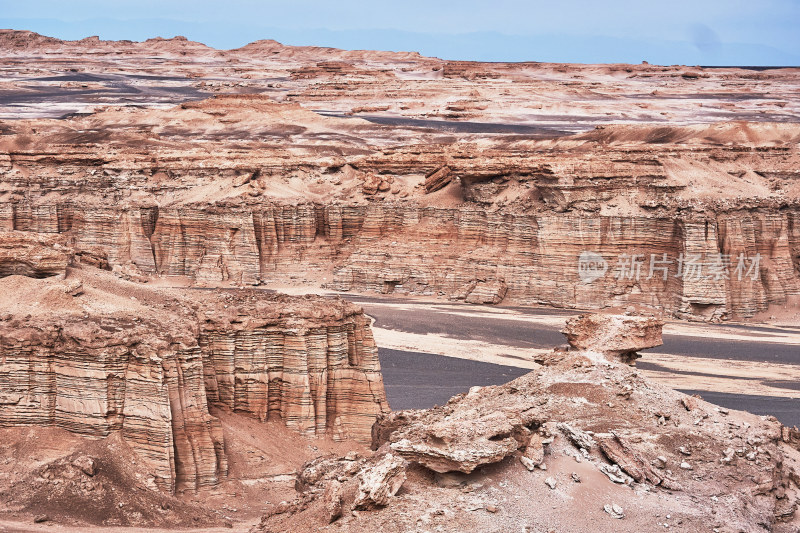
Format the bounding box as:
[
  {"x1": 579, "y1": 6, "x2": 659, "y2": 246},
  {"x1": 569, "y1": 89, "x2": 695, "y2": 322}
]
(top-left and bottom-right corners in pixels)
[{"x1": 334, "y1": 209, "x2": 800, "y2": 318}]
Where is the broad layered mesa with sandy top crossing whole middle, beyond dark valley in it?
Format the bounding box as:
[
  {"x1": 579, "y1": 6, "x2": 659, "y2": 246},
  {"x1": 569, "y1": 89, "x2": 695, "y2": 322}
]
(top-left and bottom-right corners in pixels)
[{"x1": 0, "y1": 92, "x2": 800, "y2": 320}]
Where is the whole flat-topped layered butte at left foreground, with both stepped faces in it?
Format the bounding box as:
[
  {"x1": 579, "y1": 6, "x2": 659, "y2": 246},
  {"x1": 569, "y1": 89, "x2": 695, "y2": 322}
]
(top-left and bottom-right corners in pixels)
[{"x1": 0, "y1": 270, "x2": 388, "y2": 490}]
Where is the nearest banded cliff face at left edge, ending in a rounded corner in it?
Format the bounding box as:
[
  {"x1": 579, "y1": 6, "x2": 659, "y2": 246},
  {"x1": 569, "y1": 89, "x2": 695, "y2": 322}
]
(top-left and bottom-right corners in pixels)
[{"x1": 0, "y1": 314, "x2": 222, "y2": 490}]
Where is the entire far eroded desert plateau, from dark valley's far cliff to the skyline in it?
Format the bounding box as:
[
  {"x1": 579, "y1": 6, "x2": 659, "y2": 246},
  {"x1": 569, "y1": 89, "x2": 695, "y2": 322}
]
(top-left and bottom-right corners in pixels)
[{"x1": 0, "y1": 30, "x2": 800, "y2": 320}]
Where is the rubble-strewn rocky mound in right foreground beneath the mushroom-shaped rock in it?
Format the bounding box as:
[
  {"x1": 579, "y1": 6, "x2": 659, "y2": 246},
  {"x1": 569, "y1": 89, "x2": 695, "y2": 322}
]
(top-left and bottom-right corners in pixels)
[{"x1": 255, "y1": 326, "x2": 800, "y2": 533}]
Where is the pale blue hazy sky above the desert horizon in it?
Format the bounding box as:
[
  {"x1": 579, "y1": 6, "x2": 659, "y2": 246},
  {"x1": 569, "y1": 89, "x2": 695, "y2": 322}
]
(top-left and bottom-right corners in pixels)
[{"x1": 0, "y1": 0, "x2": 800, "y2": 65}]
